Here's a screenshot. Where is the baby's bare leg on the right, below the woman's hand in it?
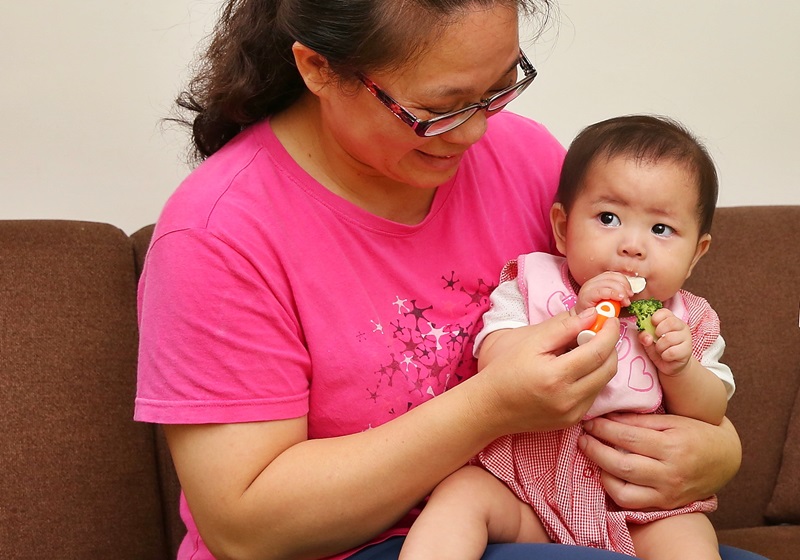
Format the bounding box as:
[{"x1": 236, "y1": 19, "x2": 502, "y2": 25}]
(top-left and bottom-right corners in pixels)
[{"x1": 629, "y1": 513, "x2": 720, "y2": 560}]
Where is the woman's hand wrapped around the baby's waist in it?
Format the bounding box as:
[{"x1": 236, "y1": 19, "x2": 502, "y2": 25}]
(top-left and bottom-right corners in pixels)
[{"x1": 581, "y1": 413, "x2": 742, "y2": 509}]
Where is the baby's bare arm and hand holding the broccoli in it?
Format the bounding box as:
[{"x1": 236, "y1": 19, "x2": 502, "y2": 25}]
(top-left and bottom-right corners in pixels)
[{"x1": 639, "y1": 309, "x2": 728, "y2": 425}]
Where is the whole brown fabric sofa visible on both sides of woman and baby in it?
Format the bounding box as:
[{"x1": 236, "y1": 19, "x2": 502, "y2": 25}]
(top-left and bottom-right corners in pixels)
[{"x1": 0, "y1": 206, "x2": 800, "y2": 560}]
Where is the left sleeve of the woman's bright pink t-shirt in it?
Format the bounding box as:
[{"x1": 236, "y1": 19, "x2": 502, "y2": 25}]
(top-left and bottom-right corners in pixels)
[{"x1": 135, "y1": 229, "x2": 310, "y2": 424}]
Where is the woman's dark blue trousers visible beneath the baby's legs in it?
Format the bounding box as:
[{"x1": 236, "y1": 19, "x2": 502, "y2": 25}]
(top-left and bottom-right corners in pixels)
[{"x1": 351, "y1": 537, "x2": 766, "y2": 560}]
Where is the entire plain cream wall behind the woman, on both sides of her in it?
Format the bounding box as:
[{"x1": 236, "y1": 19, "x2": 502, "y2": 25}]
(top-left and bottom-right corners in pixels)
[{"x1": 0, "y1": 0, "x2": 800, "y2": 232}]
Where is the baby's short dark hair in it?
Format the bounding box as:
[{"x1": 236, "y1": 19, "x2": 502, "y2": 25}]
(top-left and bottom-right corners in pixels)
[{"x1": 556, "y1": 115, "x2": 719, "y2": 235}]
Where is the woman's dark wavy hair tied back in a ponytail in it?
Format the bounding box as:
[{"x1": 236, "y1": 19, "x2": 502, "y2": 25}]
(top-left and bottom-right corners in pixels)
[{"x1": 175, "y1": 0, "x2": 548, "y2": 159}]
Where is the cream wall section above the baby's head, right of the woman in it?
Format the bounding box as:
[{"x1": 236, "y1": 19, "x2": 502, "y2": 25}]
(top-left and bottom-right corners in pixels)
[{"x1": 516, "y1": 0, "x2": 800, "y2": 210}]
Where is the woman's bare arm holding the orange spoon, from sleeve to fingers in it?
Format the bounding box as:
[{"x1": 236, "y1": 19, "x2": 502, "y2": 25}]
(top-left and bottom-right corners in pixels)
[{"x1": 166, "y1": 313, "x2": 619, "y2": 560}]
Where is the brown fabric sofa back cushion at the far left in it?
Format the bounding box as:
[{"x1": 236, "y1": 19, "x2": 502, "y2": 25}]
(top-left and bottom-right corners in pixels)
[{"x1": 0, "y1": 221, "x2": 168, "y2": 560}]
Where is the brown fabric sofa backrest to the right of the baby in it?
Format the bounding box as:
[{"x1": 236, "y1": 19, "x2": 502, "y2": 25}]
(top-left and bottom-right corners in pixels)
[{"x1": 686, "y1": 206, "x2": 800, "y2": 528}]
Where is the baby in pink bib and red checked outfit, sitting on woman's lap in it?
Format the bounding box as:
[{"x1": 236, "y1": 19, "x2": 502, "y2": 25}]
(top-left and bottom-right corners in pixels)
[{"x1": 400, "y1": 116, "x2": 734, "y2": 560}]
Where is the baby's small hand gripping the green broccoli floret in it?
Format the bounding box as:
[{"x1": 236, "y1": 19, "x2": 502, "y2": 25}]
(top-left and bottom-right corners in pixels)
[{"x1": 639, "y1": 308, "x2": 692, "y2": 376}]
